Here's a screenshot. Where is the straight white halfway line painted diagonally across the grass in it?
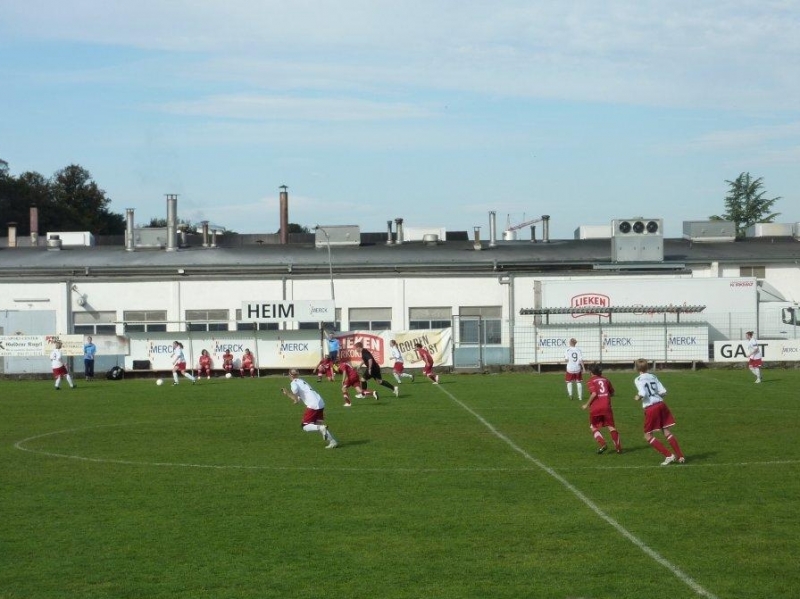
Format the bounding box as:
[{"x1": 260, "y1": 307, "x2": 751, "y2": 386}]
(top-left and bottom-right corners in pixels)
[{"x1": 439, "y1": 387, "x2": 717, "y2": 599}]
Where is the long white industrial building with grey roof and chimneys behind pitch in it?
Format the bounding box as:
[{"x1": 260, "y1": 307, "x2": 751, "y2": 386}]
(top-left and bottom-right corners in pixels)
[{"x1": 0, "y1": 199, "x2": 800, "y2": 374}]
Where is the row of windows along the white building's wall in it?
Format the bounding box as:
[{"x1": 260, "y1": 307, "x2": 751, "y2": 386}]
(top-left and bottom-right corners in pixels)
[{"x1": 73, "y1": 306, "x2": 501, "y2": 344}]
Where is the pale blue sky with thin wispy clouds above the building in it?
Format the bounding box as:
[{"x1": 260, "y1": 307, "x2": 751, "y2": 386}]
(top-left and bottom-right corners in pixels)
[{"x1": 0, "y1": 0, "x2": 800, "y2": 238}]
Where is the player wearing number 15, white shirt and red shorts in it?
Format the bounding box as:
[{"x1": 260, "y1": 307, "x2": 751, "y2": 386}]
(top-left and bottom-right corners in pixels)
[{"x1": 633, "y1": 359, "x2": 686, "y2": 466}]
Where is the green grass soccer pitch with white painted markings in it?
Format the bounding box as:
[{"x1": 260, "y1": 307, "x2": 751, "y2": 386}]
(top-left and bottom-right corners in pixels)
[{"x1": 0, "y1": 370, "x2": 800, "y2": 599}]
